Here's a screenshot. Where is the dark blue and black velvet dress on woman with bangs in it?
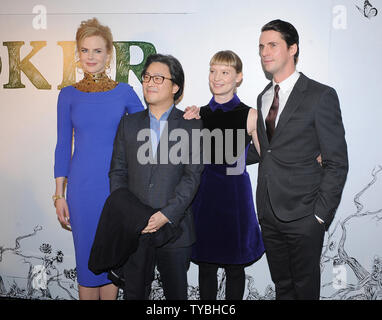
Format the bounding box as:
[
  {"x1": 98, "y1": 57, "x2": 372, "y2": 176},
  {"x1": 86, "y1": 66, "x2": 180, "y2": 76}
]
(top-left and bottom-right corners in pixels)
[{"x1": 192, "y1": 95, "x2": 264, "y2": 265}]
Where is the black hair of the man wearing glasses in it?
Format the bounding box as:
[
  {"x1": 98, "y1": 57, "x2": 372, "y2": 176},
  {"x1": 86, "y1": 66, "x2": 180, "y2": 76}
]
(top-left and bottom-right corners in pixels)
[{"x1": 142, "y1": 53, "x2": 184, "y2": 102}]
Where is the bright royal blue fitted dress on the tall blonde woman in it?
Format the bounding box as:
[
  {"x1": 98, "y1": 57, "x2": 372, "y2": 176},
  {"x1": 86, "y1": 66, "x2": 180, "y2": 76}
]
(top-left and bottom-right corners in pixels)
[{"x1": 54, "y1": 83, "x2": 144, "y2": 287}]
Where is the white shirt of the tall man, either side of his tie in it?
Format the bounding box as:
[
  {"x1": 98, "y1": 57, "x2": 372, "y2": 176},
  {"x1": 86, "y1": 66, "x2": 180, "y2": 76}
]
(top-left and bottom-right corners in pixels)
[{"x1": 261, "y1": 70, "x2": 300, "y2": 126}]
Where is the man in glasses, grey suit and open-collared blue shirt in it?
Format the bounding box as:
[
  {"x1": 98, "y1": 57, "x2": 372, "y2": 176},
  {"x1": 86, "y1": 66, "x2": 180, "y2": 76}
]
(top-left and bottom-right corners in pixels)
[{"x1": 109, "y1": 54, "x2": 203, "y2": 300}]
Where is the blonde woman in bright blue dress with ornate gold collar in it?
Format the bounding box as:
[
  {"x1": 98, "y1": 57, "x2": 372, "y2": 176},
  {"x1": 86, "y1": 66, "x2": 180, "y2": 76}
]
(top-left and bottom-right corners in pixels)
[{"x1": 53, "y1": 18, "x2": 144, "y2": 300}]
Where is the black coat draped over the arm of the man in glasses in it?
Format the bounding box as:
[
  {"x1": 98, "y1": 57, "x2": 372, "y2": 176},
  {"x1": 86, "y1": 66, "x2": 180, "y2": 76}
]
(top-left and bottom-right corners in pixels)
[{"x1": 88, "y1": 188, "x2": 181, "y2": 274}]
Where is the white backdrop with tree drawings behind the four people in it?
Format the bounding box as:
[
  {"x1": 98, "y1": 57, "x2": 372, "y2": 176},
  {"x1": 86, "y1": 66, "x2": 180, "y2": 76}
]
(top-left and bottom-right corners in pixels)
[{"x1": 0, "y1": 0, "x2": 382, "y2": 299}]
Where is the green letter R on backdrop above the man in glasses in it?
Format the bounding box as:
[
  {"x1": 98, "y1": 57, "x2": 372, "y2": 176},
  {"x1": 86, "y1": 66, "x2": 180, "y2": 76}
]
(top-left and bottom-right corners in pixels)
[{"x1": 114, "y1": 41, "x2": 156, "y2": 83}]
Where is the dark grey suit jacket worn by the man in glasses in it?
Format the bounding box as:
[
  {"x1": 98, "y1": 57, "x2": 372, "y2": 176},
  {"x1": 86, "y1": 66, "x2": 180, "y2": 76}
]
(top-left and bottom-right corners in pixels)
[{"x1": 109, "y1": 107, "x2": 203, "y2": 247}]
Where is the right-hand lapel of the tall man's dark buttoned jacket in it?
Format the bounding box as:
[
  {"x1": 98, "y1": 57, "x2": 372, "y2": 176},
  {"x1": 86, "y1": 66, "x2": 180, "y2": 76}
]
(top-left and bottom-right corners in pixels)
[{"x1": 272, "y1": 73, "x2": 309, "y2": 141}]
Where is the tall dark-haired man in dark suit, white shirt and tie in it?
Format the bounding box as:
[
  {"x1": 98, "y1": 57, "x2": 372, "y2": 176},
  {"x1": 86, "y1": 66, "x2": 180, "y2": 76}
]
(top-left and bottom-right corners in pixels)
[{"x1": 256, "y1": 20, "x2": 348, "y2": 299}]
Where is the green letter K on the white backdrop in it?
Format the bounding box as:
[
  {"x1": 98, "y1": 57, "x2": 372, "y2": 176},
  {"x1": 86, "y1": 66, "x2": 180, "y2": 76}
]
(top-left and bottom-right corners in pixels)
[{"x1": 3, "y1": 41, "x2": 51, "y2": 89}]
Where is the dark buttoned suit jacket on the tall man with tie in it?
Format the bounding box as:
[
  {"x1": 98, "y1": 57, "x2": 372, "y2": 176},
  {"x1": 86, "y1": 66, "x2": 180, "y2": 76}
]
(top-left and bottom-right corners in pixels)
[{"x1": 256, "y1": 73, "x2": 348, "y2": 228}]
